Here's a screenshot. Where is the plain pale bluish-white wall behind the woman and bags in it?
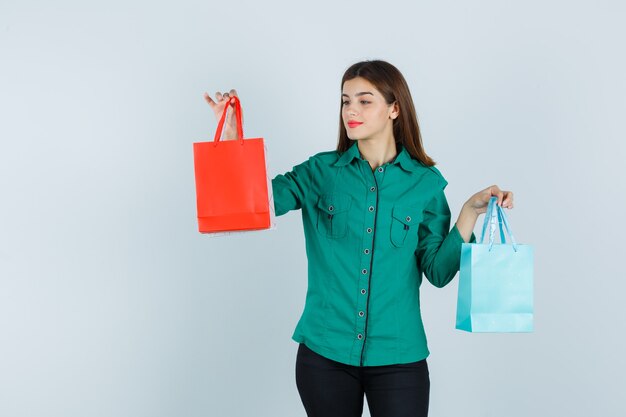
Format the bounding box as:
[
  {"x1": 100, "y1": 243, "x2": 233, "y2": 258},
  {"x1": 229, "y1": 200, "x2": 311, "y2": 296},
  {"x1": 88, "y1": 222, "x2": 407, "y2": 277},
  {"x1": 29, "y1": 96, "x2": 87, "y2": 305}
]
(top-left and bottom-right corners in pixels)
[{"x1": 0, "y1": 0, "x2": 626, "y2": 417}]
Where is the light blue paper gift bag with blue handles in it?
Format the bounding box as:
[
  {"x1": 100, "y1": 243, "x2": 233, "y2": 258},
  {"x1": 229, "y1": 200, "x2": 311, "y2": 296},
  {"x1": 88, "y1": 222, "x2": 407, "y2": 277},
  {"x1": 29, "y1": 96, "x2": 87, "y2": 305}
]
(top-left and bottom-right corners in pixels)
[{"x1": 456, "y1": 197, "x2": 534, "y2": 332}]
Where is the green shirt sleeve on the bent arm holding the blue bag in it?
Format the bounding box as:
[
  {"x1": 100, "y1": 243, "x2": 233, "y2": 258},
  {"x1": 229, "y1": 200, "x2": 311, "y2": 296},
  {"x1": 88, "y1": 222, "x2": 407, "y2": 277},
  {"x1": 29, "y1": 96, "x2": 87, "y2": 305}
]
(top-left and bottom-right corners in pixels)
[{"x1": 416, "y1": 189, "x2": 476, "y2": 288}]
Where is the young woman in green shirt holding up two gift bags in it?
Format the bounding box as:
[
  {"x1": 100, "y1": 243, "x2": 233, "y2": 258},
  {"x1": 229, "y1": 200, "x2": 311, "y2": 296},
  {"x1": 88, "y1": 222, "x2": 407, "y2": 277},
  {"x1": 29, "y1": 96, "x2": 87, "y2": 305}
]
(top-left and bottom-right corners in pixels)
[{"x1": 205, "y1": 61, "x2": 513, "y2": 417}]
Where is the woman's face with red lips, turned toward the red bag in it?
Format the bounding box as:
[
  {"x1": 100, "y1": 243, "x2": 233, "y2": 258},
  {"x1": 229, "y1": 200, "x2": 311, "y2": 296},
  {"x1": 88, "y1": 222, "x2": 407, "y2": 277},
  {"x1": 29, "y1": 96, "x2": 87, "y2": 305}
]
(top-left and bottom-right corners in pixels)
[{"x1": 341, "y1": 77, "x2": 398, "y2": 141}]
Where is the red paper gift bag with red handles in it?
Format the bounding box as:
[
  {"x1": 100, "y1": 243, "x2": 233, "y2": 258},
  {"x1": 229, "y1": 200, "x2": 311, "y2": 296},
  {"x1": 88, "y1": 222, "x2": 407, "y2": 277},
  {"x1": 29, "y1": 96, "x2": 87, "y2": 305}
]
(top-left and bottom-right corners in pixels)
[{"x1": 193, "y1": 97, "x2": 270, "y2": 233}]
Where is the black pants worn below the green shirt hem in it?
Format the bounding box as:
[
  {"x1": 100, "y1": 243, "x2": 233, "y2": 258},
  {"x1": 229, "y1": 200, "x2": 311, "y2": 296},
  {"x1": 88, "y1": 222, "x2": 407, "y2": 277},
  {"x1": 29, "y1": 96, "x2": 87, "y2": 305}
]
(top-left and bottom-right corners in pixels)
[{"x1": 296, "y1": 343, "x2": 430, "y2": 417}]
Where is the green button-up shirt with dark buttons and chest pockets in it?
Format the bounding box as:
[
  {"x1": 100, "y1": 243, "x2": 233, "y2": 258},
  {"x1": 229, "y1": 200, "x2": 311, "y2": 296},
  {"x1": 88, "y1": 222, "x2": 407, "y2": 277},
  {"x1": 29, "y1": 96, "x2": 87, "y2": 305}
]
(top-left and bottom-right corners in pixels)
[{"x1": 272, "y1": 142, "x2": 474, "y2": 366}]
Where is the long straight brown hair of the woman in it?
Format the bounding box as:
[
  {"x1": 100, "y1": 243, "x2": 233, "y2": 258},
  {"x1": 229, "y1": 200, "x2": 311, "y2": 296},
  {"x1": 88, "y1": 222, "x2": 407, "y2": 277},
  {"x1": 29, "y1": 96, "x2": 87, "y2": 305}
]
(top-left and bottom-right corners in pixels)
[{"x1": 337, "y1": 60, "x2": 435, "y2": 166}]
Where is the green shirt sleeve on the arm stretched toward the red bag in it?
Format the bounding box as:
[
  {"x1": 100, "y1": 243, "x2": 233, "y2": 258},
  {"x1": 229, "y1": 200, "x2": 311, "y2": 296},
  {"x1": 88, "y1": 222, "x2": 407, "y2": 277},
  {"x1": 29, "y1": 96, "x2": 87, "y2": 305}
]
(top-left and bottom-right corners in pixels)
[{"x1": 272, "y1": 160, "x2": 311, "y2": 216}]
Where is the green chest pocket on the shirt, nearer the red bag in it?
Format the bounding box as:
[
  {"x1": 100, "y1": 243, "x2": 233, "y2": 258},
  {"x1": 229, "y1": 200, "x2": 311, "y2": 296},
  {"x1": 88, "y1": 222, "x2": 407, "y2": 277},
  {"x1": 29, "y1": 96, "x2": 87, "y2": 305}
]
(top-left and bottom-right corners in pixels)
[{"x1": 317, "y1": 194, "x2": 352, "y2": 239}]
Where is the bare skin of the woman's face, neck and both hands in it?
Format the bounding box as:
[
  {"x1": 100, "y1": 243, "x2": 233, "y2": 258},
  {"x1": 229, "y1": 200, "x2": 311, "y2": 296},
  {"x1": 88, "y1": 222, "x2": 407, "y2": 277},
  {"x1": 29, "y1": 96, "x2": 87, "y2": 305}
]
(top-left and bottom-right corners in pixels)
[{"x1": 204, "y1": 81, "x2": 513, "y2": 242}]
